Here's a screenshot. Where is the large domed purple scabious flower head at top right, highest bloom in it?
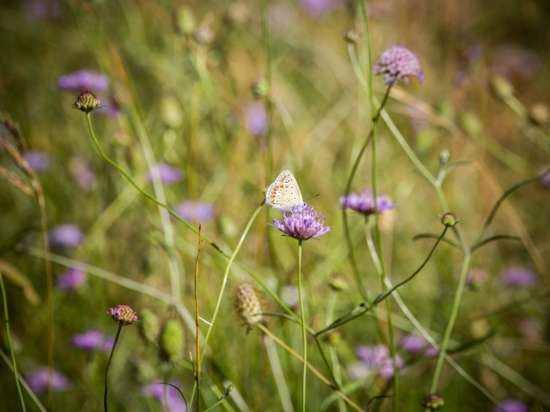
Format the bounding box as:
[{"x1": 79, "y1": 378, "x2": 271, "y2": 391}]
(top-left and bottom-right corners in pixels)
[{"x1": 372, "y1": 45, "x2": 424, "y2": 86}]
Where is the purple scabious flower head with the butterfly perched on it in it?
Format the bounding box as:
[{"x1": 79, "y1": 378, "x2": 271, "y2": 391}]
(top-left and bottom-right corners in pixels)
[{"x1": 273, "y1": 204, "x2": 330, "y2": 240}]
